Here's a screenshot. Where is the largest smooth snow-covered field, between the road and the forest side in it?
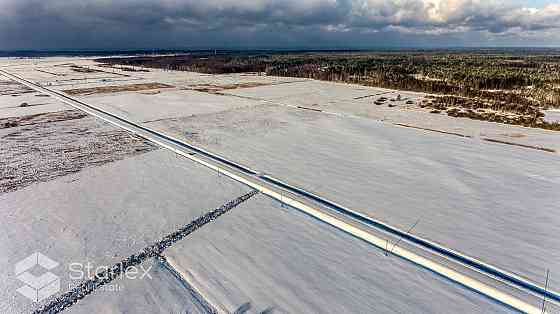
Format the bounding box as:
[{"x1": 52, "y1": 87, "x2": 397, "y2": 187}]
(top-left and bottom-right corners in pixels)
[{"x1": 151, "y1": 106, "x2": 560, "y2": 292}]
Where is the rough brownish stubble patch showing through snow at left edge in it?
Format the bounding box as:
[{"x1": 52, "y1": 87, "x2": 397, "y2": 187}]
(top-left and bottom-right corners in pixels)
[{"x1": 0, "y1": 110, "x2": 156, "y2": 194}]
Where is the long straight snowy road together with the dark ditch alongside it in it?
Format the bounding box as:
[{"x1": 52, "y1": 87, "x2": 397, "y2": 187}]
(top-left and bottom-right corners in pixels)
[{"x1": 0, "y1": 70, "x2": 560, "y2": 314}]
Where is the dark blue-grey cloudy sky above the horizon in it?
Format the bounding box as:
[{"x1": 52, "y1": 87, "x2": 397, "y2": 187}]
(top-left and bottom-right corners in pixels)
[{"x1": 0, "y1": 0, "x2": 560, "y2": 50}]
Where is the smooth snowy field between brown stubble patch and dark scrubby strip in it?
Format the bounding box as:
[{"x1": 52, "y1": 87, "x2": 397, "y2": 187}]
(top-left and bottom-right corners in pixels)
[{"x1": 0, "y1": 150, "x2": 247, "y2": 313}]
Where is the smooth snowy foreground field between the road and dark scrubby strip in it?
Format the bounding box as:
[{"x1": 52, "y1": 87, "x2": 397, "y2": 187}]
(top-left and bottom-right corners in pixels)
[{"x1": 166, "y1": 196, "x2": 508, "y2": 313}]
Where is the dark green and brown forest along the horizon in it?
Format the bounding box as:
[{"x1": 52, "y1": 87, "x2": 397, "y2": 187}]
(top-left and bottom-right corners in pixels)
[{"x1": 98, "y1": 51, "x2": 560, "y2": 108}]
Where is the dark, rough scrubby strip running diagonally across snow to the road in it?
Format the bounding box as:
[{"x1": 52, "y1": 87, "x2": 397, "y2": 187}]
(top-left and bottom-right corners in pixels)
[{"x1": 33, "y1": 190, "x2": 259, "y2": 314}]
